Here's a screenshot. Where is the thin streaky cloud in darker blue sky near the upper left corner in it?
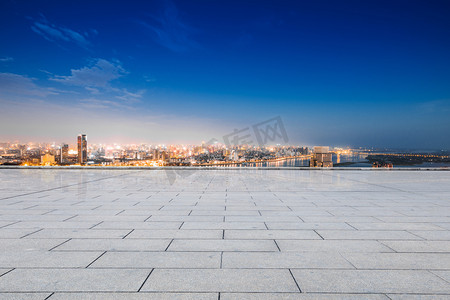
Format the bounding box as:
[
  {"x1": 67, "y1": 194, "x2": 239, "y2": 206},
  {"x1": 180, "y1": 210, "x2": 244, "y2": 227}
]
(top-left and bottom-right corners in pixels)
[{"x1": 31, "y1": 15, "x2": 93, "y2": 49}]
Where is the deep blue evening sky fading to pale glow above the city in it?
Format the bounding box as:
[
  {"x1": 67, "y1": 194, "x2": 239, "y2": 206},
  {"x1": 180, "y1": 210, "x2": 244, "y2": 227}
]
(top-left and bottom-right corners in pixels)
[{"x1": 0, "y1": 0, "x2": 450, "y2": 149}]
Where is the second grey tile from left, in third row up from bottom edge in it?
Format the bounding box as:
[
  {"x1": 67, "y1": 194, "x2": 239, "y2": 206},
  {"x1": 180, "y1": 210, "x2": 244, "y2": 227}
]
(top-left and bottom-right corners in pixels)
[{"x1": 91, "y1": 252, "x2": 221, "y2": 269}]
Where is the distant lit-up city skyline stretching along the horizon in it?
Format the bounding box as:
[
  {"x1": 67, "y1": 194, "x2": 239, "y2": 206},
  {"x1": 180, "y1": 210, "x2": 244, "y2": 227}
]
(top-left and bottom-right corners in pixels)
[{"x1": 0, "y1": 134, "x2": 450, "y2": 168}]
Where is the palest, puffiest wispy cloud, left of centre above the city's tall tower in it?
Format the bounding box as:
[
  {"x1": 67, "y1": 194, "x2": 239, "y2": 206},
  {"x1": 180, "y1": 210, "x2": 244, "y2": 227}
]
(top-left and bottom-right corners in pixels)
[{"x1": 51, "y1": 58, "x2": 128, "y2": 87}]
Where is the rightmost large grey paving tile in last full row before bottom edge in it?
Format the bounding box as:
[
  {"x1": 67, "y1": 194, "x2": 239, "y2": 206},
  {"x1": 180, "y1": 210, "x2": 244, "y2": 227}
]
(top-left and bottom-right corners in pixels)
[{"x1": 292, "y1": 270, "x2": 450, "y2": 294}]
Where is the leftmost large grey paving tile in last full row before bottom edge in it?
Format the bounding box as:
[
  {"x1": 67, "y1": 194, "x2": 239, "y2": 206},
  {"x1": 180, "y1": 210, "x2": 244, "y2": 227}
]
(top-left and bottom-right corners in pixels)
[{"x1": 0, "y1": 269, "x2": 150, "y2": 292}]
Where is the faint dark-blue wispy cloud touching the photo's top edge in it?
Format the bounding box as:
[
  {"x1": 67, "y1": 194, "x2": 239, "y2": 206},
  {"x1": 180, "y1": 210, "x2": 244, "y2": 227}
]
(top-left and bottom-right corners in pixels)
[{"x1": 137, "y1": 1, "x2": 199, "y2": 52}]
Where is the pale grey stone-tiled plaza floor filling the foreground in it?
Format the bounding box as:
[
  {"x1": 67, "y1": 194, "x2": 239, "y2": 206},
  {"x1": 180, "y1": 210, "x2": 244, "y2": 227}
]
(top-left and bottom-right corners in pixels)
[{"x1": 0, "y1": 169, "x2": 450, "y2": 300}]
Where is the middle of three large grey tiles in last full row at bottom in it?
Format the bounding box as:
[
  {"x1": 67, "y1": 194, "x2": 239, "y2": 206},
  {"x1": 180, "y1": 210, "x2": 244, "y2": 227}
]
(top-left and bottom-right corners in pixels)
[{"x1": 142, "y1": 269, "x2": 298, "y2": 292}]
